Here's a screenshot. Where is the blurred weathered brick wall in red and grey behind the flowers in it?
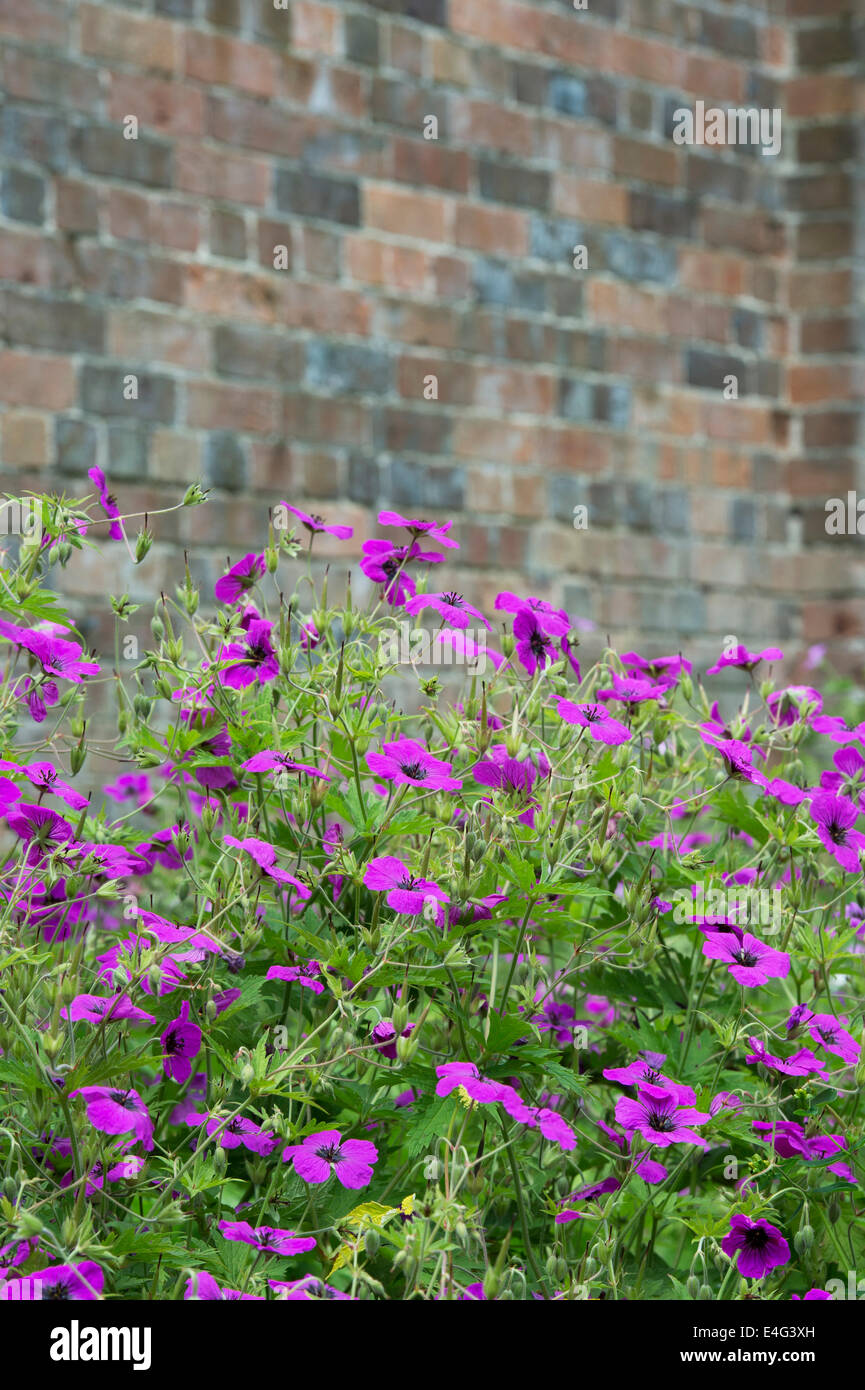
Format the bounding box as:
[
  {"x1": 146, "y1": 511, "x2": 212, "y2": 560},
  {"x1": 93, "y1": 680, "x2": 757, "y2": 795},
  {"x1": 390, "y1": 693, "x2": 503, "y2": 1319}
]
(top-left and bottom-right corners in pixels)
[{"x1": 0, "y1": 0, "x2": 865, "y2": 672}]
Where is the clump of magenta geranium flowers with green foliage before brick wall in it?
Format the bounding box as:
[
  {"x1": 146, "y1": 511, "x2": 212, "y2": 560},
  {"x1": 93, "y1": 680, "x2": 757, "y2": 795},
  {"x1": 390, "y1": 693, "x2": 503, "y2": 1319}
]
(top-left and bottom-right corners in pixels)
[{"x1": 0, "y1": 468, "x2": 865, "y2": 1302}]
